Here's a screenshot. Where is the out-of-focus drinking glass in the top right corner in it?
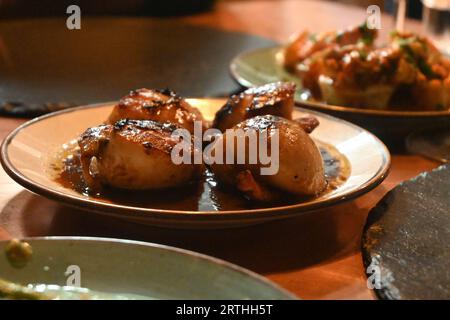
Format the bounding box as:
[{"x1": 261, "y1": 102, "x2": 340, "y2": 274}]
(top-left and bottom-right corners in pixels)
[{"x1": 422, "y1": 0, "x2": 450, "y2": 55}]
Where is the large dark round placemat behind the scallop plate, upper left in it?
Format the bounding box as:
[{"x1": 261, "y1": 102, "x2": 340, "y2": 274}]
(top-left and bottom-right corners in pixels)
[{"x1": 0, "y1": 18, "x2": 274, "y2": 116}]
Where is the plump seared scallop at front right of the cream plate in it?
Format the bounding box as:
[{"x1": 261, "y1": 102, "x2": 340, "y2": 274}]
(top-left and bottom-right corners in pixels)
[{"x1": 210, "y1": 115, "x2": 326, "y2": 201}]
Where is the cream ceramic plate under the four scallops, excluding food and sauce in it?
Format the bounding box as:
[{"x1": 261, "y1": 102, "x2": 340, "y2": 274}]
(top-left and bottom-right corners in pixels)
[{"x1": 1, "y1": 99, "x2": 390, "y2": 228}]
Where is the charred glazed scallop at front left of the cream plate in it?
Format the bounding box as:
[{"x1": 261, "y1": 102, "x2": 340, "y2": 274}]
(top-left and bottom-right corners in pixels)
[{"x1": 78, "y1": 120, "x2": 197, "y2": 190}]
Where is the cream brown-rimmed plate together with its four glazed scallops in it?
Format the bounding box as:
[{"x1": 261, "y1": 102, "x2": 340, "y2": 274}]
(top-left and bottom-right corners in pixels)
[{"x1": 1, "y1": 82, "x2": 390, "y2": 228}]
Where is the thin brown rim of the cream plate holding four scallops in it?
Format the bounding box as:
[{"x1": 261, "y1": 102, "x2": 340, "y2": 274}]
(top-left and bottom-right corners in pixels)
[{"x1": 0, "y1": 98, "x2": 391, "y2": 222}]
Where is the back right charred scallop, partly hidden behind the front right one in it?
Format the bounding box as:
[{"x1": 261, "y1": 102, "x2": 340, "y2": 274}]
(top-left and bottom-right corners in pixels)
[{"x1": 213, "y1": 82, "x2": 295, "y2": 131}]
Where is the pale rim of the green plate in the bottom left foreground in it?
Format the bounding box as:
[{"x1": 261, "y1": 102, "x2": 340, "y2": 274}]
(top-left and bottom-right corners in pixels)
[{"x1": 0, "y1": 236, "x2": 299, "y2": 300}]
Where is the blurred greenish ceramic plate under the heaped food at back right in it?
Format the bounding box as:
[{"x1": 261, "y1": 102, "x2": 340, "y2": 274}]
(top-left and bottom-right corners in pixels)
[{"x1": 230, "y1": 46, "x2": 450, "y2": 140}]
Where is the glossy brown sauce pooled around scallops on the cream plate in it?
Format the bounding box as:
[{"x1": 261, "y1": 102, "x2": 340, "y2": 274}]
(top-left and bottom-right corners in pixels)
[{"x1": 52, "y1": 142, "x2": 350, "y2": 213}]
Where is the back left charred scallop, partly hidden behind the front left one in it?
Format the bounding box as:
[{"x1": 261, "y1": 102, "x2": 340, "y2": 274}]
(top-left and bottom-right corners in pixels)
[{"x1": 107, "y1": 89, "x2": 204, "y2": 132}]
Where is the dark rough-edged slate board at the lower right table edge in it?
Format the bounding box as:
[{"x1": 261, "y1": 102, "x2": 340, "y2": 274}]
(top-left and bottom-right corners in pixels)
[{"x1": 362, "y1": 165, "x2": 450, "y2": 299}]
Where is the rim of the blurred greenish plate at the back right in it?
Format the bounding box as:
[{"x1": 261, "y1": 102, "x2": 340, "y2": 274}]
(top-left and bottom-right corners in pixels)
[{"x1": 229, "y1": 45, "x2": 450, "y2": 118}]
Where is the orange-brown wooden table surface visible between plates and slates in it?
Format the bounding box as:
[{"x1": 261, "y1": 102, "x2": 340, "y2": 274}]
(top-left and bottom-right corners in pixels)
[{"x1": 0, "y1": 0, "x2": 439, "y2": 299}]
